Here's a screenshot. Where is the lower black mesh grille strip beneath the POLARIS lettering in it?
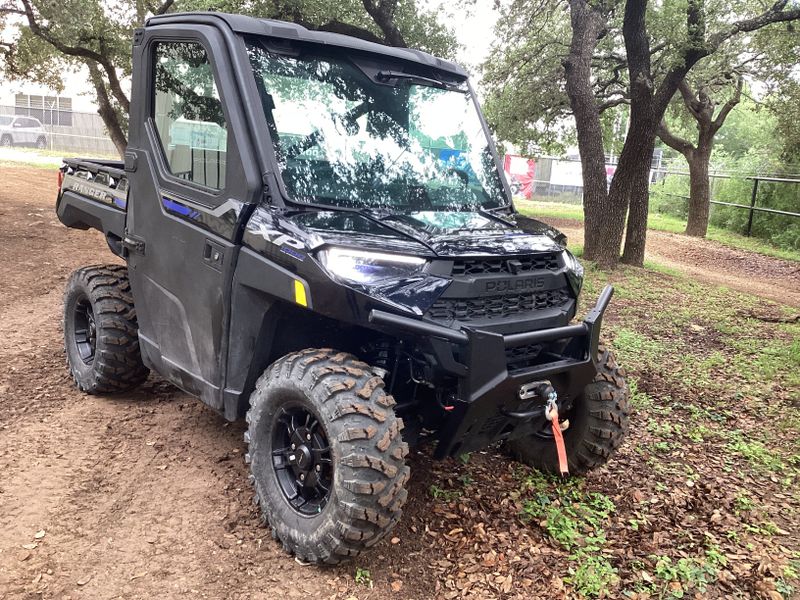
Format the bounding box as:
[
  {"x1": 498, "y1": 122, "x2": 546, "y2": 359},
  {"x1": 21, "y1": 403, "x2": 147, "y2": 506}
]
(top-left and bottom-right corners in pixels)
[{"x1": 428, "y1": 289, "x2": 569, "y2": 321}]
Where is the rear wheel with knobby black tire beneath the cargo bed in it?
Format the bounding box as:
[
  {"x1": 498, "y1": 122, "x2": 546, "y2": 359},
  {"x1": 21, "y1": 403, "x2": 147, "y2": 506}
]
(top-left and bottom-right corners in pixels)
[{"x1": 64, "y1": 265, "x2": 148, "y2": 394}]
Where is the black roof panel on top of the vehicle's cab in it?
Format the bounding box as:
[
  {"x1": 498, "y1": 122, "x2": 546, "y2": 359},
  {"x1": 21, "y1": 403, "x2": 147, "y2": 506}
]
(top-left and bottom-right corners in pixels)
[{"x1": 145, "y1": 11, "x2": 467, "y2": 77}]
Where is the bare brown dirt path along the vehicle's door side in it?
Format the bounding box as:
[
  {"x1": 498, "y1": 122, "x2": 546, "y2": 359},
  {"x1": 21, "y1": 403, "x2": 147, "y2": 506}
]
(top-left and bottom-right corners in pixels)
[{"x1": 0, "y1": 168, "x2": 362, "y2": 598}]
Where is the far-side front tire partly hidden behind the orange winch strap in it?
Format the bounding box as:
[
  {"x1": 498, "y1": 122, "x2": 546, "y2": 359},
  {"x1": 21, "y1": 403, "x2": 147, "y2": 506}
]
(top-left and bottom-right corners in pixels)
[{"x1": 508, "y1": 346, "x2": 630, "y2": 475}]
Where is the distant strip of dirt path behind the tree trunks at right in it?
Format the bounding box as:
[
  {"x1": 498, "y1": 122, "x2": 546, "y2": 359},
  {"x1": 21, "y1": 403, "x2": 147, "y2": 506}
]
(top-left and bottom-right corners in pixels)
[{"x1": 542, "y1": 218, "x2": 800, "y2": 307}]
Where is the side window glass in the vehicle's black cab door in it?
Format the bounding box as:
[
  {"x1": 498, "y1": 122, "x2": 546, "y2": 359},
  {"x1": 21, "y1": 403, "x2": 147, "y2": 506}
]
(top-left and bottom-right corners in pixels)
[{"x1": 153, "y1": 42, "x2": 228, "y2": 190}]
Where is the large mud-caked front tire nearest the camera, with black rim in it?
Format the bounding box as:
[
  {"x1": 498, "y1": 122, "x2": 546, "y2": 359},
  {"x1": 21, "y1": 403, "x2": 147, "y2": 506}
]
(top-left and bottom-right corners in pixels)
[{"x1": 245, "y1": 349, "x2": 409, "y2": 565}]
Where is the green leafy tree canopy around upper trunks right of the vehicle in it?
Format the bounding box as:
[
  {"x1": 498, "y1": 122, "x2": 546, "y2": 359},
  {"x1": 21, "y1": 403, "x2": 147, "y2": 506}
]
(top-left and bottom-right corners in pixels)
[{"x1": 483, "y1": 0, "x2": 800, "y2": 153}]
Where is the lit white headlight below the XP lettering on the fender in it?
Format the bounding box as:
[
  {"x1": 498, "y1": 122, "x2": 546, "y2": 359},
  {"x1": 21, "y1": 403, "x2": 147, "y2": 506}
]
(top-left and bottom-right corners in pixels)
[{"x1": 318, "y1": 247, "x2": 427, "y2": 284}]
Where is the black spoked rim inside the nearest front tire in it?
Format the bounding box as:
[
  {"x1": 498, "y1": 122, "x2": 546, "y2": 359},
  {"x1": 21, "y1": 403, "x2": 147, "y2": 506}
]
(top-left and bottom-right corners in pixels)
[{"x1": 272, "y1": 406, "x2": 333, "y2": 516}]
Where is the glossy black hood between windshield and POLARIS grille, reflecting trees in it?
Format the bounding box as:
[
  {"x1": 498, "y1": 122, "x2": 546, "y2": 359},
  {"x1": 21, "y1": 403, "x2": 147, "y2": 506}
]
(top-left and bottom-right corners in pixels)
[{"x1": 290, "y1": 211, "x2": 566, "y2": 257}]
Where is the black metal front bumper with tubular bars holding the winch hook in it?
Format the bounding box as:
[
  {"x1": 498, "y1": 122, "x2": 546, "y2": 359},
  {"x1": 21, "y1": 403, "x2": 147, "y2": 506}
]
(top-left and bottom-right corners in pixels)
[{"x1": 369, "y1": 285, "x2": 614, "y2": 458}]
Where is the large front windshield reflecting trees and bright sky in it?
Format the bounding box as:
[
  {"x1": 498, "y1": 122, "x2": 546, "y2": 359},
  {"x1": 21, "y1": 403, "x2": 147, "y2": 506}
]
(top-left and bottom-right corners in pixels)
[{"x1": 249, "y1": 44, "x2": 508, "y2": 212}]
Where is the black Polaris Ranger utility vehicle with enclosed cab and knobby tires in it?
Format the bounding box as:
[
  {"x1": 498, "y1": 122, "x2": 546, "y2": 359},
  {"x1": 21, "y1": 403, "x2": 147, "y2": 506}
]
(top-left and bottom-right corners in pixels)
[{"x1": 57, "y1": 13, "x2": 628, "y2": 564}]
